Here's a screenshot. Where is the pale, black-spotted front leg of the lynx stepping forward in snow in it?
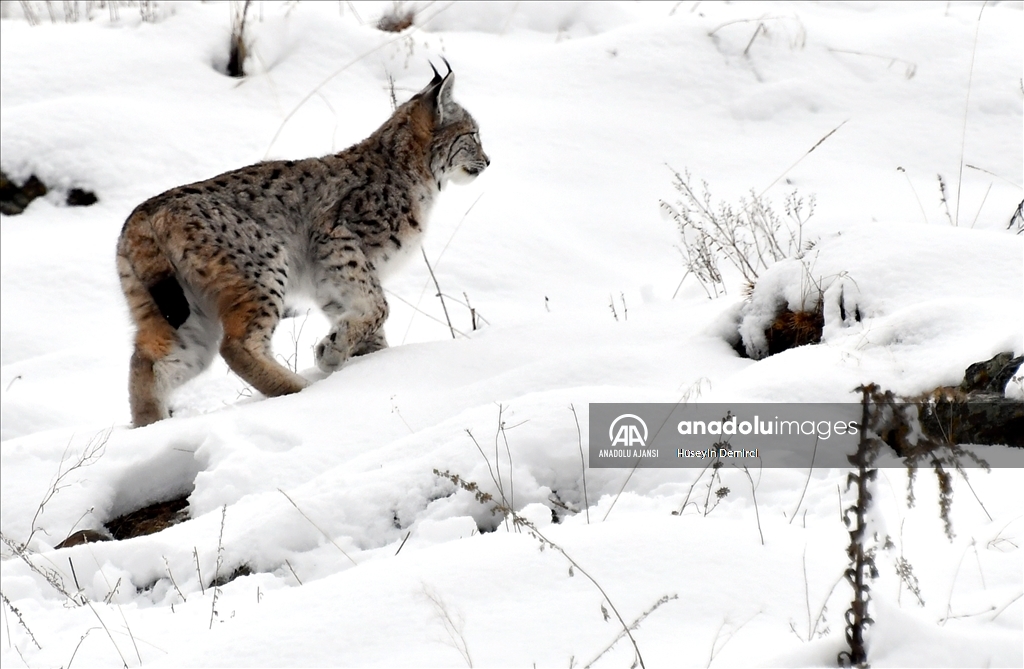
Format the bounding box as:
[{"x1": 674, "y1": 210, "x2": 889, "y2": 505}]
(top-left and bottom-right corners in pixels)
[{"x1": 314, "y1": 244, "x2": 388, "y2": 373}]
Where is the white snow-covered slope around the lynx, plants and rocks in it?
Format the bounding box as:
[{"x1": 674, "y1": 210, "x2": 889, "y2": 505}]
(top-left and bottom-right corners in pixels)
[{"x1": 0, "y1": 2, "x2": 1024, "y2": 667}]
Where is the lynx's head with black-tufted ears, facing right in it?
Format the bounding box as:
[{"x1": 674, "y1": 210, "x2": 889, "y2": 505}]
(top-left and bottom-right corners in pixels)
[{"x1": 417, "y1": 60, "x2": 490, "y2": 189}]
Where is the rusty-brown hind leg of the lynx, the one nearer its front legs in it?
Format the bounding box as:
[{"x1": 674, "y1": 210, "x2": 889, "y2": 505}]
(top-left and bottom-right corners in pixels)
[{"x1": 219, "y1": 282, "x2": 308, "y2": 398}]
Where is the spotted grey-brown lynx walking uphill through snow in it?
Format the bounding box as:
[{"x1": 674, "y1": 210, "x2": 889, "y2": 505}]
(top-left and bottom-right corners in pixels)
[{"x1": 117, "y1": 61, "x2": 490, "y2": 427}]
